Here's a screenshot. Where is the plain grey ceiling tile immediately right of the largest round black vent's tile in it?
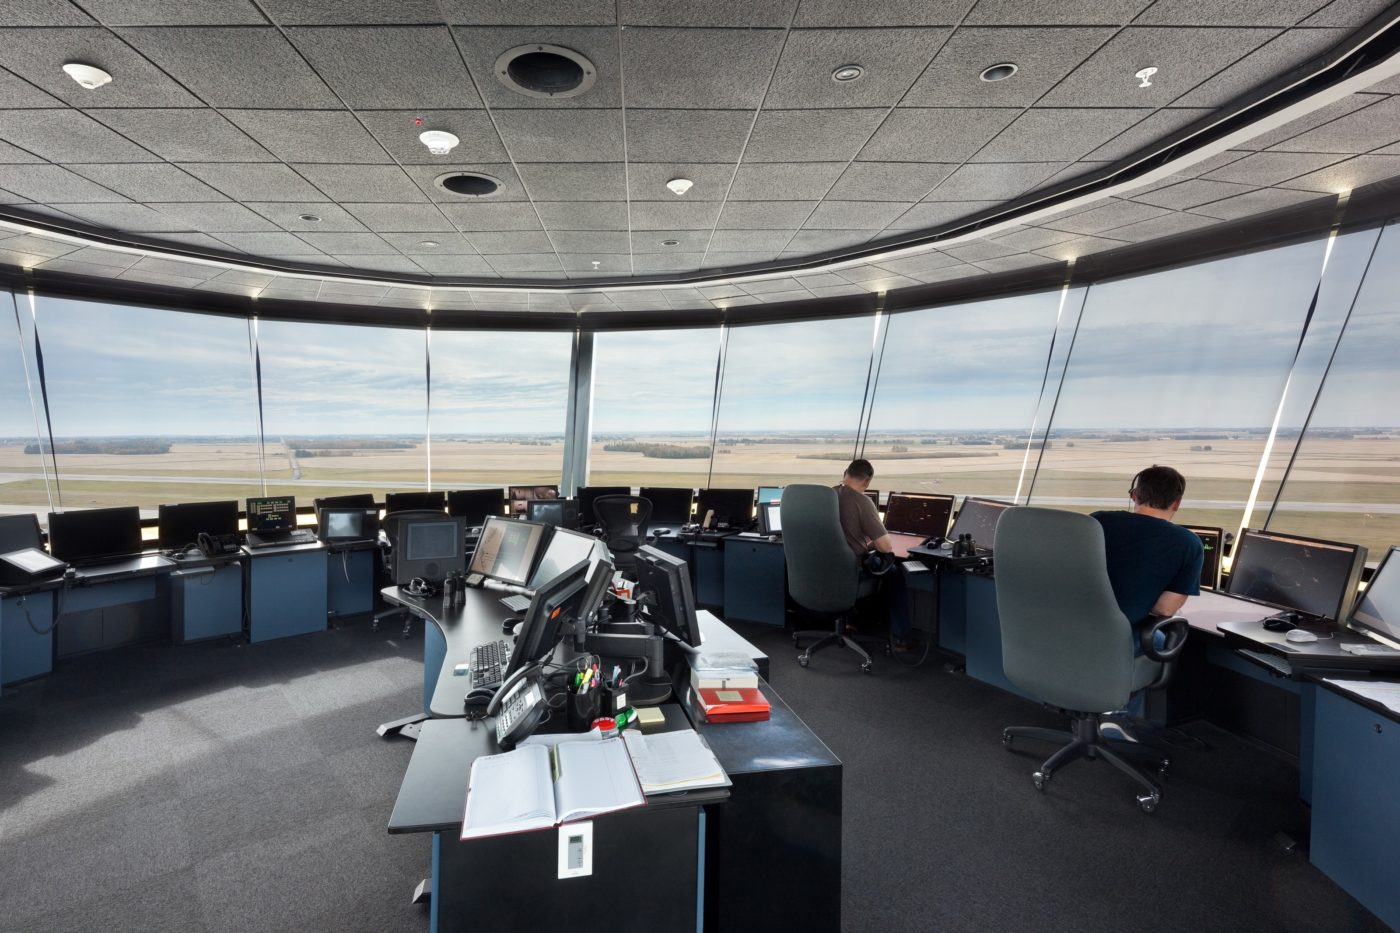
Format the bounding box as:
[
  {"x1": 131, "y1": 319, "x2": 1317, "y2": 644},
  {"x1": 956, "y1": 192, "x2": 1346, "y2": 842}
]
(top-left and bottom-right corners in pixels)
[{"x1": 622, "y1": 27, "x2": 784, "y2": 109}]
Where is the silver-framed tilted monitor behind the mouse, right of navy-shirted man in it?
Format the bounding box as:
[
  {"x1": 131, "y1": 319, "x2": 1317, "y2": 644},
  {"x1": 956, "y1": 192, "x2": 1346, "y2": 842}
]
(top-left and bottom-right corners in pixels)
[{"x1": 1225, "y1": 528, "x2": 1366, "y2": 621}]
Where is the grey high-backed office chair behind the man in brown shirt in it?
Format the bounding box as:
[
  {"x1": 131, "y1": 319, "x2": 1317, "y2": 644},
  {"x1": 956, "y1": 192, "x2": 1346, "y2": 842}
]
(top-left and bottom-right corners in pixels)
[{"x1": 778, "y1": 483, "x2": 888, "y2": 674}]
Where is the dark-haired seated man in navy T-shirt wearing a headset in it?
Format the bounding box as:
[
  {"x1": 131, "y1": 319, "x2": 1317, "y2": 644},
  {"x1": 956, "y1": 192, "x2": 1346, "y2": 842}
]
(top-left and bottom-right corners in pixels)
[{"x1": 1093, "y1": 465, "x2": 1205, "y2": 740}]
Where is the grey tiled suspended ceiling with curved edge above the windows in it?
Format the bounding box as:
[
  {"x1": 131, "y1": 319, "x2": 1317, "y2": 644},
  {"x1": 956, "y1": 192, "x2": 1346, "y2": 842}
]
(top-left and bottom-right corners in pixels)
[{"x1": 0, "y1": 0, "x2": 1400, "y2": 311}]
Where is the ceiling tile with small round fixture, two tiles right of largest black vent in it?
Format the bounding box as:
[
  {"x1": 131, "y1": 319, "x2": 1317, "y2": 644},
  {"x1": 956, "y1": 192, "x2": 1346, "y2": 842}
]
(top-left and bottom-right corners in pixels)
[{"x1": 763, "y1": 29, "x2": 951, "y2": 109}]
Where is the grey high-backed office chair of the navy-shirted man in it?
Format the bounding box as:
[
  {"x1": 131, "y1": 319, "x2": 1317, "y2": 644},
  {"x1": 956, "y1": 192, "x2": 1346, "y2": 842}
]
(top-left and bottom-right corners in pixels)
[{"x1": 997, "y1": 506, "x2": 1189, "y2": 813}]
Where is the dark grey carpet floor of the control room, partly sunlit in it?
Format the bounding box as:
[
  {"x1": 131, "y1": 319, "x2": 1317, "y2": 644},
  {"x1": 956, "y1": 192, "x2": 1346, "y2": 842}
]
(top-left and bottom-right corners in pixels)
[{"x1": 0, "y1": 610, "x2": 1385, "y2": 933}]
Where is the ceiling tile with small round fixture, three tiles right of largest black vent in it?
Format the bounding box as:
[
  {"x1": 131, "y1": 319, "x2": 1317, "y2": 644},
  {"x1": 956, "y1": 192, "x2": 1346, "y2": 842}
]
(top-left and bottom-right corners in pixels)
[{"x1": 902, "y1": 27, "x2": 1113, "y2": 106}]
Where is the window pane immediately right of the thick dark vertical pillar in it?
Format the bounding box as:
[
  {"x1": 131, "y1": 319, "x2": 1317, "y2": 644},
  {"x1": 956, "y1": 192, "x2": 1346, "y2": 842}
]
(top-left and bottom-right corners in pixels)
[{"x1": 588, "y1": 328, "x2": 720, "y2": 486}]
